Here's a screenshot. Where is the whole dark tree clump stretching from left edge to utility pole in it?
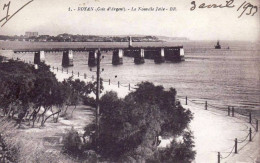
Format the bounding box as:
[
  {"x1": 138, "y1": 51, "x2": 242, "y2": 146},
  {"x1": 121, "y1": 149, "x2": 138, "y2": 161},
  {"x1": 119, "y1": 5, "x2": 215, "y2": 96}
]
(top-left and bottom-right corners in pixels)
[{"x1": 0, "y1": 60, "x2": 94, "y2": 127}]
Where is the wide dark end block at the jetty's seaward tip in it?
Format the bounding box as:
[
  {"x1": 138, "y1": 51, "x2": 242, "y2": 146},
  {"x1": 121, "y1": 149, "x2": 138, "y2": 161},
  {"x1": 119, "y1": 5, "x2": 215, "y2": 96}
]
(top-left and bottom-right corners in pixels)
[{"x1": 164, "y1": 46, "x2": 184, "y2": 62}]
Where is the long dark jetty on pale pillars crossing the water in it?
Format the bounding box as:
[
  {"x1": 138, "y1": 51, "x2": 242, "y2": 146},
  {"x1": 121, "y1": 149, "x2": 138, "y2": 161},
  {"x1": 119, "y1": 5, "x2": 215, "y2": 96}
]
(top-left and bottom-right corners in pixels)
[{"x1": 10, "y1": 37, "x2": 184, "y2": 67}]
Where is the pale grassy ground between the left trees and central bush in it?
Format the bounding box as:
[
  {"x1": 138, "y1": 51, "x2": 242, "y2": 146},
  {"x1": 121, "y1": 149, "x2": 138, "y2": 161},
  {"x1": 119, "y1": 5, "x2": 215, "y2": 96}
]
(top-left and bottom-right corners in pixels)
[{"x1": 0, "y1": 106, "x2": 93, "y2": 163}]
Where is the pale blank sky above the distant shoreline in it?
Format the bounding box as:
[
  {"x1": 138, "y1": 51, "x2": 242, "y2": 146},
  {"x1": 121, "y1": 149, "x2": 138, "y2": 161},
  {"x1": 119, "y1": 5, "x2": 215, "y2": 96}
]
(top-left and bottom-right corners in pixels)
[{"x1": 0, "y1": 0, "x2": 260, "y2": 41}]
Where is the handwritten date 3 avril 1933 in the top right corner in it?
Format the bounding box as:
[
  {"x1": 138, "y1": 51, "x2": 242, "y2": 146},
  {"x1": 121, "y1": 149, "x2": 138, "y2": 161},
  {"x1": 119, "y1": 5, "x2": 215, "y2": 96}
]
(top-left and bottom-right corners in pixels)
[{"x1": 190, "y1": 0, "x2": 258, "y2": 18}]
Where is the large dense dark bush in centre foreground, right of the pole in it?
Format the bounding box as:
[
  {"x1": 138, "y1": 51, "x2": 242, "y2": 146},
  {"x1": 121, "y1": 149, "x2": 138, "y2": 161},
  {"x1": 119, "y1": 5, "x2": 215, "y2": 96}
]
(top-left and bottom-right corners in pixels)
[{"x1": 85, "y1": 82, "x2": 194, "y2": 162}]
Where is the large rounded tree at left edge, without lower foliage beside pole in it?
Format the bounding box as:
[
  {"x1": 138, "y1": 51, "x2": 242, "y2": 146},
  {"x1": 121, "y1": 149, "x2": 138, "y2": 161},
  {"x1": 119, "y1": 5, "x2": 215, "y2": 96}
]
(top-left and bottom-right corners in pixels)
[{"x1": 0, "y1": 60, "x2": 67, "y2": 126}]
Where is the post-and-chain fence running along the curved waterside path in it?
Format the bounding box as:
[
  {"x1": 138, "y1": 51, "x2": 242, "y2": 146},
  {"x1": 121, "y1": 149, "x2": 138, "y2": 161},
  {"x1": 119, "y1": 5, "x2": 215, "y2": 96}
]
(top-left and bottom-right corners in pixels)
[{"x1": 16, "y1": 60, "x2": 259, "y2": 163}]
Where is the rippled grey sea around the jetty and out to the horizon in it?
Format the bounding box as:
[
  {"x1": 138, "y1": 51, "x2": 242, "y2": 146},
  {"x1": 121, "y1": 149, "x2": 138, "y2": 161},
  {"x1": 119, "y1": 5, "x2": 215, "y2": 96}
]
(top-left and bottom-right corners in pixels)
[{"x1": 0, "y1": 41, "x2": 260, "y2": 109}]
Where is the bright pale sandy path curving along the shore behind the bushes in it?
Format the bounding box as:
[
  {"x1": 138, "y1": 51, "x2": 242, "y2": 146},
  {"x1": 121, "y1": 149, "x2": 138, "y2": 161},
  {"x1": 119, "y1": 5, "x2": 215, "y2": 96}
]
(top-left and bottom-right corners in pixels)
[{"x1": 52, "y1": 69, "x2": 260, "y2": 163}]
